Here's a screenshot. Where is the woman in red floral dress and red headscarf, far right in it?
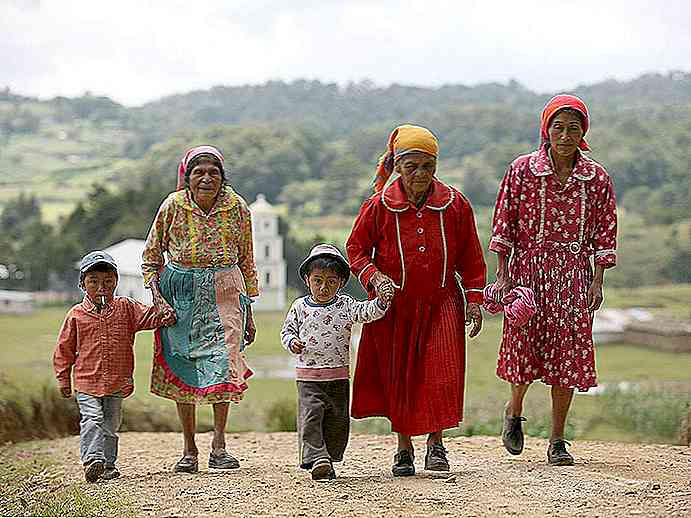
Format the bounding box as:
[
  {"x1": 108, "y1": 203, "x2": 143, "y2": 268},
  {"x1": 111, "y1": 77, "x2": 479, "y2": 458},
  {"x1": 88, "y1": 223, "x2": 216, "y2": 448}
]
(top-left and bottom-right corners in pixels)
[{"x1": 489, "y1": 95, "x2": 617, "y2": 465}]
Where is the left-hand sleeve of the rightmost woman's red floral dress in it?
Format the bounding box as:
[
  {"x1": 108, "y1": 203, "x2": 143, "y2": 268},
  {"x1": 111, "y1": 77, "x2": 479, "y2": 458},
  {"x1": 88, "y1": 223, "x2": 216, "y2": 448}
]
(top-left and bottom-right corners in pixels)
[{"x1": 489, "y1": 164, "x2": 521, "y2": 255}]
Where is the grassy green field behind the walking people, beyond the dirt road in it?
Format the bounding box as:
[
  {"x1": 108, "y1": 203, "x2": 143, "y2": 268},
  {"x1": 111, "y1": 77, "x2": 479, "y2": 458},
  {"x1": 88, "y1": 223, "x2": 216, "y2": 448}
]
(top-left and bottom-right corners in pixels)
[{"x1": 0, "y1": 286, "x2": 691, "y2": 441}]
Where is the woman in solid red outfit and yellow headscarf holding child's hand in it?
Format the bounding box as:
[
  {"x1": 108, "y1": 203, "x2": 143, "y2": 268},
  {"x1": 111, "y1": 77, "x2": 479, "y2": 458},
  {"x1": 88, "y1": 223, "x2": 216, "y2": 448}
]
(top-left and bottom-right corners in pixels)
[{"x1": 347, "y1": 125, "x2": 486, "y2": 476}]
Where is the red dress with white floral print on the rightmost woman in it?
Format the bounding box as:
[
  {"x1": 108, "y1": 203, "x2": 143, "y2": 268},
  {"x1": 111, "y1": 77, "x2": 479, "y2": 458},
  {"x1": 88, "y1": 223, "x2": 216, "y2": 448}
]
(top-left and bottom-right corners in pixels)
[{"x1": 489, "y1": 146, "x2": 617, "y2": 390}]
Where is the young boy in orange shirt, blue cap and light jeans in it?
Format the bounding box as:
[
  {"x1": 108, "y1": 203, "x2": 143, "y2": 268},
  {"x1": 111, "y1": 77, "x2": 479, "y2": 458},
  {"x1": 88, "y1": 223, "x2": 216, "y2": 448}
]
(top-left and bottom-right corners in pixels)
[{"x1": 53, "y1": 251, "x2": 175, "y2": 482}]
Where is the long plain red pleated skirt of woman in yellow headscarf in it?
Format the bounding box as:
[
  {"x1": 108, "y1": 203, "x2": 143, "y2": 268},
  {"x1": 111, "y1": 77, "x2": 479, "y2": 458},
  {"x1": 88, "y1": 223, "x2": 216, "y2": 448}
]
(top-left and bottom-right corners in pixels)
[{"x1": 351, "y1": 285, "x2": 465, "y2": 435}]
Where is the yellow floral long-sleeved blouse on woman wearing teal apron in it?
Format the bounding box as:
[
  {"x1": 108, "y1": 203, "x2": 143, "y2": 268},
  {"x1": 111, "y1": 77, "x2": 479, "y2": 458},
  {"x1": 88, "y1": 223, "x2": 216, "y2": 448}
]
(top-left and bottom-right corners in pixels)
[{"x1": 142, "y1": 186, "x2": 259, "y2": 297}]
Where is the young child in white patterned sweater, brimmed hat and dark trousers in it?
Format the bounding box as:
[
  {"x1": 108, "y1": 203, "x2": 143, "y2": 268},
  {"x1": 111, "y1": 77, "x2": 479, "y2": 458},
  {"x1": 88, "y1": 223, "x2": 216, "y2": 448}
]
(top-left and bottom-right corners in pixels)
[{"x1": 281, "y1": 244, "x2": 393, "y2": 480}]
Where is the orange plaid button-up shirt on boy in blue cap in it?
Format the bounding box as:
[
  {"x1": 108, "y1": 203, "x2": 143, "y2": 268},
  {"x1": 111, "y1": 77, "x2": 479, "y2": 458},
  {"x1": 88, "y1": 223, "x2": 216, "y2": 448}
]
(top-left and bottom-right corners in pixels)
[{"x1": 53, "y1": 297, "x2": 165, "y2": 397}]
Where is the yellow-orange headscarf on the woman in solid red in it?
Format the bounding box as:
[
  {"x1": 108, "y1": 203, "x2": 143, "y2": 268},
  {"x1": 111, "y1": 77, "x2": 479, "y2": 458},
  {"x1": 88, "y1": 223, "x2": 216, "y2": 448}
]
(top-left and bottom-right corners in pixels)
[{"x1": 374, "y1": 124, "x2": 439, "y2": 193}]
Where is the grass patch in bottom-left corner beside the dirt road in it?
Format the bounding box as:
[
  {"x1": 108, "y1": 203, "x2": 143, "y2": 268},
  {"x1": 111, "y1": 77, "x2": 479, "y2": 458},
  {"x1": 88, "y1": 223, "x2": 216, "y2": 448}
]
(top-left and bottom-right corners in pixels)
[{"x1": 0, "y1": 441, "x2": 134, "y2": 517}]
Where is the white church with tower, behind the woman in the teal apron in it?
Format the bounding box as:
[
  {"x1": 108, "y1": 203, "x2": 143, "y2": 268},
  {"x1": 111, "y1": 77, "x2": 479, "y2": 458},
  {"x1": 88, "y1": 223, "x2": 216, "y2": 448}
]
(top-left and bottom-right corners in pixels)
[{"x1": 99, "y1": 194, "x2": 286, "y2": 311}]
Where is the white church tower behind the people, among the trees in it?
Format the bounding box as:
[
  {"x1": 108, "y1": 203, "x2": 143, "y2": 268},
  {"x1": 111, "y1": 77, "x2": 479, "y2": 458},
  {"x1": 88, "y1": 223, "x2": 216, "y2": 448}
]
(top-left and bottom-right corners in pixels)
[{"x1": 250, "y1": 194, "x2": 286, "y2": 311}]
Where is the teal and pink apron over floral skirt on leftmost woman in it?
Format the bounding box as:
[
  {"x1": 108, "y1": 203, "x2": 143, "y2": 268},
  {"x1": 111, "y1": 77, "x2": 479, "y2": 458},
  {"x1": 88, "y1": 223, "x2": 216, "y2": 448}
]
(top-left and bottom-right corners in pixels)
[{"x1": 151, "y1": 264, "x2": 252, "y2": 403}]
